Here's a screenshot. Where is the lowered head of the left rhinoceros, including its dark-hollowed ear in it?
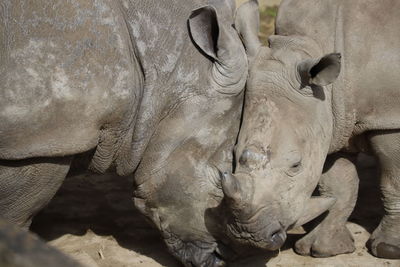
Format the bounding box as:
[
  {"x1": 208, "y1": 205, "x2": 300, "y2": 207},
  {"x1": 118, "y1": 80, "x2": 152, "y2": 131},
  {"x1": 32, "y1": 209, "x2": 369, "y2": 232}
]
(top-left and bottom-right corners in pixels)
[{"x1": 130, "y1": 0, "x2": 248, "y2": 266}]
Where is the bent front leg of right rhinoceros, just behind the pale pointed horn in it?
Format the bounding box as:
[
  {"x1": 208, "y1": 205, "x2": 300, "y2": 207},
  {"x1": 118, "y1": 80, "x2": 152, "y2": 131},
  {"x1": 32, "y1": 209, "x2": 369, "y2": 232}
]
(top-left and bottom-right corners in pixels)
[{"x1": 295, "y1": 154, "x2": 358, "y2": 257}]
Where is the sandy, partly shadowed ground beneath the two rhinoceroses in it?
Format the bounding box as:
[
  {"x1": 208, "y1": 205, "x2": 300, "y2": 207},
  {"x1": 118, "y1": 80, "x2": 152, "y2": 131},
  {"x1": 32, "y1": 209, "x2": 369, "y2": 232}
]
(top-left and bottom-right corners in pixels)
[{"x1": 32, "y1": 157, "x2": 400, "y2": 267}]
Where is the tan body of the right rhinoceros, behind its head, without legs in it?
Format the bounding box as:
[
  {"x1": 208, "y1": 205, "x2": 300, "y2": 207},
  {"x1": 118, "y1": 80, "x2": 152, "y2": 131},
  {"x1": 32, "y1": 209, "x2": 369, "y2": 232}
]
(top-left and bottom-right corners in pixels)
[{"x1": 276, "y1": 0, "x2": 400, "y2": 152}]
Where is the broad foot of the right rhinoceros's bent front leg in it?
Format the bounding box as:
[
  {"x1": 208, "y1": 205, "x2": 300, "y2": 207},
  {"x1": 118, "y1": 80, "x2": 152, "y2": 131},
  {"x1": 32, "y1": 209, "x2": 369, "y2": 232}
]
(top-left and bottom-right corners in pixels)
[{"x1": 295, "y1": 224, "x2": 355, "y2": 258}]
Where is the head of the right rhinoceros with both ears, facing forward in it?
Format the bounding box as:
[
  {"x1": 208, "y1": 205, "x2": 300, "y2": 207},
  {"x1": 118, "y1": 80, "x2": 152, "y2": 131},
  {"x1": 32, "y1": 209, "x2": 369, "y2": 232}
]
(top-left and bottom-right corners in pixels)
[{"x1": 222, "y1": 1, "x2": 340, "y2": 250}]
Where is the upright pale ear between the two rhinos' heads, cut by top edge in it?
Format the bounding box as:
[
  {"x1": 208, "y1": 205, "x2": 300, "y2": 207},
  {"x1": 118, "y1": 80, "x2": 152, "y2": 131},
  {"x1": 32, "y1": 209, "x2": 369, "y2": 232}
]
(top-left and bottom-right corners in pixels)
[{"x1": 235, "y1": 0, "x2": 261, "y2": 61}]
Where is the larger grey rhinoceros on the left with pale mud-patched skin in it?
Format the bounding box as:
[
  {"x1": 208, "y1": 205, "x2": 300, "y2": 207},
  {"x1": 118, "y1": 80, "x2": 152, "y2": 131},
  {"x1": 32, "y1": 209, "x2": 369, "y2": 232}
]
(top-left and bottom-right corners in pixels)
[{"x1": 0, "y1": 0, "x2": 248, "y2": 266}]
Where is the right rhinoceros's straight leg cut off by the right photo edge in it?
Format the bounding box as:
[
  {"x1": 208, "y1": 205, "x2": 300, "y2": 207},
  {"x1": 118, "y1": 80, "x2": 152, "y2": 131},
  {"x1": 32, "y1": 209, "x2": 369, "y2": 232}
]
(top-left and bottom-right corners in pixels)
[{"x1": 368, "y1": 131, "x2": 400, "y2": 259}]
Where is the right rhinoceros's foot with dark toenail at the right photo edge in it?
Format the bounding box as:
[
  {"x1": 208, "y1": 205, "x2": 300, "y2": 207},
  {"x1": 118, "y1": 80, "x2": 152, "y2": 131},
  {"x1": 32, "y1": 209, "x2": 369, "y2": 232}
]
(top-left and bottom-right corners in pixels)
[{"x1": 367, "y1": 227, "x2": 400, "y2": 259}]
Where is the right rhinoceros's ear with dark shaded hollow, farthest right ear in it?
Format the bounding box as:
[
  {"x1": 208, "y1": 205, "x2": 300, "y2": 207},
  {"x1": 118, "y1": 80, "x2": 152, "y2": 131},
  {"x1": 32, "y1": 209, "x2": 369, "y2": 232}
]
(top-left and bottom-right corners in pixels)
[{"x1": 297, "y1": 53, "x2": 341, "y2": 86}]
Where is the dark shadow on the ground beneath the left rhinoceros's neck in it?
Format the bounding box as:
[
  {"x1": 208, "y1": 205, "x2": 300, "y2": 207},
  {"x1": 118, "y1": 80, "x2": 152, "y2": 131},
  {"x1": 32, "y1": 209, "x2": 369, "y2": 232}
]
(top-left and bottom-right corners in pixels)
[{"x1": 31, "y1": 174, "x2": 179, "y2": 266}]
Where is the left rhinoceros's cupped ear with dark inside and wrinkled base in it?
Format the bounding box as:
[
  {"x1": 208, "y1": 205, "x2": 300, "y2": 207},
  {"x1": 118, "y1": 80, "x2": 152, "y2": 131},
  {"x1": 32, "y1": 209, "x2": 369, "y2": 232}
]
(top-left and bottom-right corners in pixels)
[{"x1": 188, "y1": 6, "x2": 248, "y2": 94}]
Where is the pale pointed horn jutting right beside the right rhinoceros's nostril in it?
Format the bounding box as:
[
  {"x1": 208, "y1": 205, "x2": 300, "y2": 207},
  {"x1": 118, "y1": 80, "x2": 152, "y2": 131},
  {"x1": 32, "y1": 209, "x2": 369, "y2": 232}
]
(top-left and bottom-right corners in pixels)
[{"x1": 294, "y1": 197, "x2": 336, "y2": 227}]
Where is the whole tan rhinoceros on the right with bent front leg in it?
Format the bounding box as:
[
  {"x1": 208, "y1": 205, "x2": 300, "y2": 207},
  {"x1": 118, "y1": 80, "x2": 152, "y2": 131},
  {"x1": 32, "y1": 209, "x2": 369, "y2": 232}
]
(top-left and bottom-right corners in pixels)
[{"x1": 223, "y1": 0, "x2": 400, "y2": 259}]
